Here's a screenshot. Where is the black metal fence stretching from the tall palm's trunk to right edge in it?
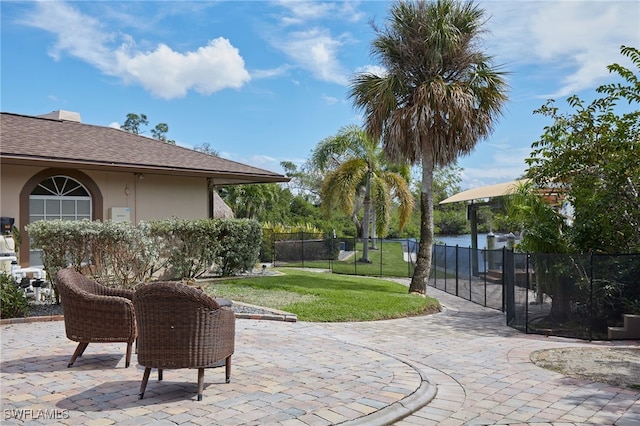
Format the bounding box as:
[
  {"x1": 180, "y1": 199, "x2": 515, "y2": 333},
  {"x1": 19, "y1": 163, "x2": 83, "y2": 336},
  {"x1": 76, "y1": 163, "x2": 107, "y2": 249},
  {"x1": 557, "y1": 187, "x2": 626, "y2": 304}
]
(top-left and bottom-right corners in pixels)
[{"x1": 429, "y1": 245, "x2": 640, "y2": 340}]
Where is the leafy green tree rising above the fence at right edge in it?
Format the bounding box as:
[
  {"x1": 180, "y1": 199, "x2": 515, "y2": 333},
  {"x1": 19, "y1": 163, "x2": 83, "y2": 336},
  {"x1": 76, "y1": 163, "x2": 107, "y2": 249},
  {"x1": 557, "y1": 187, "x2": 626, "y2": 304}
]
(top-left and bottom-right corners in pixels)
[{"x1": 527, "y1": 46, "x2": 640, "y2": 253}]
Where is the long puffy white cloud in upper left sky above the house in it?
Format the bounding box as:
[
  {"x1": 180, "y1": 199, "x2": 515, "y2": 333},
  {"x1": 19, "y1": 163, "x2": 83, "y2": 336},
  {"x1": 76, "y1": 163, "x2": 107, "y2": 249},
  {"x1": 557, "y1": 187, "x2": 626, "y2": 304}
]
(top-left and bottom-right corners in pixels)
[{"x1": 20, "y1": 2, "x2": 251, "y2": 99}]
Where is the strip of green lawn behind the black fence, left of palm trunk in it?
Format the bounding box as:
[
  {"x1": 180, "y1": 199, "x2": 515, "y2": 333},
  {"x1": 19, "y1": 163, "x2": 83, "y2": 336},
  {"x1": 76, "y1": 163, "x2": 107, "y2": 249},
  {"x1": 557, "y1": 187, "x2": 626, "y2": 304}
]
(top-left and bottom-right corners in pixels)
[{"x1": 280, "y1": 241, "x2": 413, "y2": 277}]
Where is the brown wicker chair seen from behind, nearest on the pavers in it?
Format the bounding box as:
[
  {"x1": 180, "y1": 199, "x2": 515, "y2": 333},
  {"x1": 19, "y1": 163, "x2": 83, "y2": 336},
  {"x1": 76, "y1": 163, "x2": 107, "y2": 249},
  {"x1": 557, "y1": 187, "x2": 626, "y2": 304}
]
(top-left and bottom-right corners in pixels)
[{"x1": 133, "y1": 282, "x2": 235, "y2": 401}]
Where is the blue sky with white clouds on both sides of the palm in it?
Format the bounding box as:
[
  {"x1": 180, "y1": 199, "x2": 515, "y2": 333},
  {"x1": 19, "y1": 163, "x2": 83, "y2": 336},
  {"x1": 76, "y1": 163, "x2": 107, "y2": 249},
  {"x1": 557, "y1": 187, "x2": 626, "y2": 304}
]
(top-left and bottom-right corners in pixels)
[{"x1": 0, "y1": 0, "x2": 640, "y2": 189}]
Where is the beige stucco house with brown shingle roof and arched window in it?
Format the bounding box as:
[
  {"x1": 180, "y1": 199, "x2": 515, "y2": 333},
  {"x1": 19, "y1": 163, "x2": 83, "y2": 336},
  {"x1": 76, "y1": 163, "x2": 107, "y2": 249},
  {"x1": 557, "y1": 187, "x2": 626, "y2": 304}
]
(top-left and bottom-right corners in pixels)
[{"x1": 0, "y1": 111, "x2": 289, "y2": 266}]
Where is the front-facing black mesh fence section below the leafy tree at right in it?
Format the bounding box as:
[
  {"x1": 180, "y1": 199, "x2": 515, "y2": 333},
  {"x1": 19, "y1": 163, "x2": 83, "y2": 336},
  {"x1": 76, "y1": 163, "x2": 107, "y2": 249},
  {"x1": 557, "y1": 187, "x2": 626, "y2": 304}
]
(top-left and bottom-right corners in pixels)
[{"x1": 504, "y1": 251, "x2": 640, "y2": 340}]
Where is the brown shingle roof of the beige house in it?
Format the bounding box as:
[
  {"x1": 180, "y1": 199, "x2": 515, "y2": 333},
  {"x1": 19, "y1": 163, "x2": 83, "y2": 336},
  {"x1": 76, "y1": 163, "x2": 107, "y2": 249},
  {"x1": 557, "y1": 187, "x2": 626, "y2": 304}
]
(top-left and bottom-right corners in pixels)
[{"x1": 0, "y1": 112, "x2": 289, "y2": 185}]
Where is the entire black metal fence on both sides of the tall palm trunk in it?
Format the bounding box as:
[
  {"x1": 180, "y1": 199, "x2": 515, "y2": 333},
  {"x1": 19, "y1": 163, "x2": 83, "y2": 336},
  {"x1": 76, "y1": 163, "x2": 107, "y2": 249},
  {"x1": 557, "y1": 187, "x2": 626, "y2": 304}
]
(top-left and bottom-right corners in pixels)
[{"x1": 261, "y1": 233, "x2": 640, "y2": 340}]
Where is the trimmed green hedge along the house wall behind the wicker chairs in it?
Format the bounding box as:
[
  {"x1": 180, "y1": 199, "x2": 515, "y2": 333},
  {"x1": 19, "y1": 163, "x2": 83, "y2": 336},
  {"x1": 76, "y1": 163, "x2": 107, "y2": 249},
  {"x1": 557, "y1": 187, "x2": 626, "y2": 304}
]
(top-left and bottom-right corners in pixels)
[{"x1": 26, "y1": 219, "x2": 262, "y2": 288}]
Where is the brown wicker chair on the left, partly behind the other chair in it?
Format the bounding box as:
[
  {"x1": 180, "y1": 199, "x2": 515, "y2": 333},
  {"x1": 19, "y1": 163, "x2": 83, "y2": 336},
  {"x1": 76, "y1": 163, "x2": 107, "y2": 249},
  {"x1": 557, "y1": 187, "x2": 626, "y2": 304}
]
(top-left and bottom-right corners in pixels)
[{"x1": 56, "y1": 269, "x2": 137, "y2": 367}]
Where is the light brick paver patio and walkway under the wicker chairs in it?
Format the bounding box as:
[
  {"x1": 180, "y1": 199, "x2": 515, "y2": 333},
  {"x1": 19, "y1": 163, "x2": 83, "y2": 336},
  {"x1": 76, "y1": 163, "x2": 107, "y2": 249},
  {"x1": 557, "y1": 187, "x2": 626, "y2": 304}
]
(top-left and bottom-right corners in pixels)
[{"x1": 0, "y1": 282, "x2": 640, "y2": 426}]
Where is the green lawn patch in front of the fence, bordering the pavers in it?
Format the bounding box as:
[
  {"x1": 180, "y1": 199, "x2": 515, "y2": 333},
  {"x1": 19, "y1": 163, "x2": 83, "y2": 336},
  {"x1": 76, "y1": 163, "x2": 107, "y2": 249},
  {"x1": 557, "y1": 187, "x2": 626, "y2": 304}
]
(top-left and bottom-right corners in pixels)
[{"x1": 201, "y1": 268, "x2": 440, "y2": 322}]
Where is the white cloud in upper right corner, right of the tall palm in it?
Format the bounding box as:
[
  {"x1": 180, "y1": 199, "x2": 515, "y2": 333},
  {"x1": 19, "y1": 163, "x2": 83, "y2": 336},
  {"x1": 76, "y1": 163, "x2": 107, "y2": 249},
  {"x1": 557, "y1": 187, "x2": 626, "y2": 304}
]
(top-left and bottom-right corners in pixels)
[{"x1": 482, "y1": 0, "x2": 640, "y2": 97}]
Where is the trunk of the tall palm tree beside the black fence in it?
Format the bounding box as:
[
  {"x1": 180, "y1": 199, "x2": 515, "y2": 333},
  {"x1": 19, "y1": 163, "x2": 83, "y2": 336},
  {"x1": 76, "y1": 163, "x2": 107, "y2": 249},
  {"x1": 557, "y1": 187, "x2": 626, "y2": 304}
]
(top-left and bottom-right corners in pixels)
[{"x1": 409, "y1": 149, "x2": 434, "y2": 294}]
